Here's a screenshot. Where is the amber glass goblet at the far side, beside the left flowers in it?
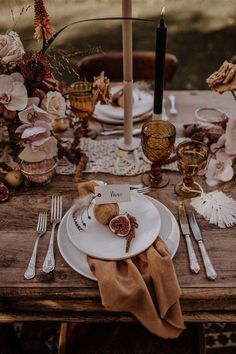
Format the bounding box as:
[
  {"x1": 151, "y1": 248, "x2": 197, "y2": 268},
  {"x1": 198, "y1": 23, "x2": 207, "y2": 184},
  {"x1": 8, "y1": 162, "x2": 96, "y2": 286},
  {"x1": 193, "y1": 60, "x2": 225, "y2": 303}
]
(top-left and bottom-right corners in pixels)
[{"x1": 69, "y1": 81, "x2": 95, "y2": 137}]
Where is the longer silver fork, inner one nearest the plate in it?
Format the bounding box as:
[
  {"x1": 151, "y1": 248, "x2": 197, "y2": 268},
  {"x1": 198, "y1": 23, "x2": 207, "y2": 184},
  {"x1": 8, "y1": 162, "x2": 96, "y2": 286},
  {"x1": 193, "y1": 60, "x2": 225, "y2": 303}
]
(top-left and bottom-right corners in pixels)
[{"x1": 43, "y1": 196, "x2": 62, "y2": 273}]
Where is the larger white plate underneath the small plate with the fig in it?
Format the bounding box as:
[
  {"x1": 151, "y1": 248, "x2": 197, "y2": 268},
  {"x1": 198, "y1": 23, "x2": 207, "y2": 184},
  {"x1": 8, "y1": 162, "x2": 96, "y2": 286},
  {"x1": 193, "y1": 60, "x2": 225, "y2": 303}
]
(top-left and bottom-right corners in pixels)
[{"x1": 57, "y1": 196, "x2": 180, "y2": 280}]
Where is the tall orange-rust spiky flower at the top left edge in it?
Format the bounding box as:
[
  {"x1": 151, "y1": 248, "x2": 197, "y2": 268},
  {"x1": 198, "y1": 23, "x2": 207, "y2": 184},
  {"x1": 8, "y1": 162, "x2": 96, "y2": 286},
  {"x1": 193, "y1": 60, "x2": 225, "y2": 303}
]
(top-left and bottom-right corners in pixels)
[{"x1": 34, "y1": 0, "x2": 53, "y2": 43}]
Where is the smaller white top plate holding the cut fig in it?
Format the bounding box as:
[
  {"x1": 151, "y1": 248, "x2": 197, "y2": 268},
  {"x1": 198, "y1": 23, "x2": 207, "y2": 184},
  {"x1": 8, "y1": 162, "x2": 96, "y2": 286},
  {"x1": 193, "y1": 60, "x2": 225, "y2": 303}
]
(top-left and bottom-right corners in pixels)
[{"x1": 67, "y1": 192, "x2": 161, "y2": 260}]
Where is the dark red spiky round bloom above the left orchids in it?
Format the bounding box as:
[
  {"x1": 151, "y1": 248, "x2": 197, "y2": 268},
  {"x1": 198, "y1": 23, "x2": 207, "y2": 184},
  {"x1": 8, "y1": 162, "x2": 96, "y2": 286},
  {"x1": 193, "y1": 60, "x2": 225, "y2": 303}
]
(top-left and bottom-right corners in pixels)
[{"x1": 19, "y1": 52, "x2": 52, "y2": 95}]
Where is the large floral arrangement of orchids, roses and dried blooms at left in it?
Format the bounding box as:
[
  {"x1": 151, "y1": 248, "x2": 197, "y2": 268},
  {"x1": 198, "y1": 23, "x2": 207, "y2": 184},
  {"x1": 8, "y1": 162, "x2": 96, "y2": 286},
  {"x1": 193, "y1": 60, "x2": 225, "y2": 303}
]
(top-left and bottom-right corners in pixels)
[{"x1": 0, "y1": 0, "x2": 110, "y2": 194}]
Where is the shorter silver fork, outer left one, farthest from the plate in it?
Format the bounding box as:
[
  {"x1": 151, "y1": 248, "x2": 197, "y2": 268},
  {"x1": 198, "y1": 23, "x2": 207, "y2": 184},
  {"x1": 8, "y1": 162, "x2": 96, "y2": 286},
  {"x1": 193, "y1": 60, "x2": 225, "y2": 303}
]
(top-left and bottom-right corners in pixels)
[{"x1": 24, "y1": 211, "x2": 47, "y2": 279}]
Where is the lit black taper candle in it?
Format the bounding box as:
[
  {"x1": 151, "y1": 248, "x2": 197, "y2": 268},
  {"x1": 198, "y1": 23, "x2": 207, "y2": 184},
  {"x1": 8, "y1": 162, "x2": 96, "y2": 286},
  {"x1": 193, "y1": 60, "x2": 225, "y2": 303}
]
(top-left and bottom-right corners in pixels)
[{"x1": 153, "y1": 14, "x2": 167, "y2": 114}]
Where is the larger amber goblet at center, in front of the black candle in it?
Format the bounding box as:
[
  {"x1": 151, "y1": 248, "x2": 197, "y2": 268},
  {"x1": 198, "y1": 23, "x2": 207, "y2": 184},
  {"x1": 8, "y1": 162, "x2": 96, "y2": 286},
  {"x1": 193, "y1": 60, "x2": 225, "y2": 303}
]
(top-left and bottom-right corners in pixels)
[{"x1": 141, "y1": 120, "x2": 176, "y2": 188}]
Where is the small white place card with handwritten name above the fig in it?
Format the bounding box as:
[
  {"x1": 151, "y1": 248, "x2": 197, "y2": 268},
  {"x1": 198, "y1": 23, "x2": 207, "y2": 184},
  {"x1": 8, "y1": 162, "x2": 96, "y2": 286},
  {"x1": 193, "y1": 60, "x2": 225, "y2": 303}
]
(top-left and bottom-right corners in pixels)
[{"x1": 95, "y1": 184, "x2": 131, "y2": 204}]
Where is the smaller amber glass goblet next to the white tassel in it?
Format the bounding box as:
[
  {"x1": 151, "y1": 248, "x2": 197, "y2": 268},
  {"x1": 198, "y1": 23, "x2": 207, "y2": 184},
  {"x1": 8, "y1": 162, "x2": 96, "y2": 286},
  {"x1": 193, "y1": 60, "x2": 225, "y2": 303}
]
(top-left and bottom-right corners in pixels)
[{"x1": 175, "y1": 140, "x2": 209, "y2": 198}]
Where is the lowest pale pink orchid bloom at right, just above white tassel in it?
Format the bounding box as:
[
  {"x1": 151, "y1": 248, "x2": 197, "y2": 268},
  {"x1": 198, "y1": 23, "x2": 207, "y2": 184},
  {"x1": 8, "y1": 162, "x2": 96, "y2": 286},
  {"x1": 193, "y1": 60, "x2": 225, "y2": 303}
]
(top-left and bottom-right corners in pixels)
[{"x1": 205, "y1": 149, "x2": 234, "y2": 186}]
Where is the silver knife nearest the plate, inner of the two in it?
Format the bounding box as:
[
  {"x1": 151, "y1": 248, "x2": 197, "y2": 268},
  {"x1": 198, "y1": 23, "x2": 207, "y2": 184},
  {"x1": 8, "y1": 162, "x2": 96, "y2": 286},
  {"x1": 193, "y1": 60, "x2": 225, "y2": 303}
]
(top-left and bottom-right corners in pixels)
[{"x1": 178, "y1": 202, "x2": 200, "y2": 274}]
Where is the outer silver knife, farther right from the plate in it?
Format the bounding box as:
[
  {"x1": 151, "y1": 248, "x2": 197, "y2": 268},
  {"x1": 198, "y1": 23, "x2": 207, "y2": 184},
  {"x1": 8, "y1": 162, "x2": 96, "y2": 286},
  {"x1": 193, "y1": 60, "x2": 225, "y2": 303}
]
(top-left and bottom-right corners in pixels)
[{"x1": 187, "y1": 210, "x2": 217, "y2": 280}]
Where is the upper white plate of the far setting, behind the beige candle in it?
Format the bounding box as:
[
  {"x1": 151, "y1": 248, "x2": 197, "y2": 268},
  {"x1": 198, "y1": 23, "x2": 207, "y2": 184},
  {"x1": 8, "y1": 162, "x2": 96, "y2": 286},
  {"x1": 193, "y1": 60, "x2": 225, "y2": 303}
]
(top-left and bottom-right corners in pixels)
[{"x1": 95, "y1": 86, "x2": 153, "y2": 120}]
